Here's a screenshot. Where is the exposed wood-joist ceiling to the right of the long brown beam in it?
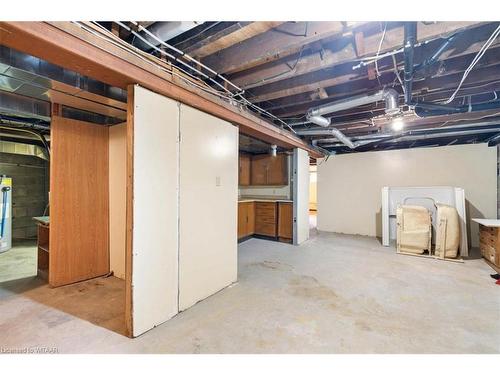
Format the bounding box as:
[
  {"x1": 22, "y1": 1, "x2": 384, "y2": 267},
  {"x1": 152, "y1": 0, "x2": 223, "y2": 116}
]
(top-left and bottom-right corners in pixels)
[{"x1": 117, "y1": 22, "x2": 500, "y2": 154}]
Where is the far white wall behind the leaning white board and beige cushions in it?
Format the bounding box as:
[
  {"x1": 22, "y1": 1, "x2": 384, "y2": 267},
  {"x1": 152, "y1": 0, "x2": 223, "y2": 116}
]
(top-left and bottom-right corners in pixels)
[{"x1": 318, "y1": 144, "x2": 497, "y2": 246}]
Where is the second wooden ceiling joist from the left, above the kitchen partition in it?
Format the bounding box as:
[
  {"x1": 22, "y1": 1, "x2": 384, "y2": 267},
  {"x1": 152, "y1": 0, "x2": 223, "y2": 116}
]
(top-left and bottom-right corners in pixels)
[{"x1": 202, "y1": 21, "x2": 345, "y2": 74}]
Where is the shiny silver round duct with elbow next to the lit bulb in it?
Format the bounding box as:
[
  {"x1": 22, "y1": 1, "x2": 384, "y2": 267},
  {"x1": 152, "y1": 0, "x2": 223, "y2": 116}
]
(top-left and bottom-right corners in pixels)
[{"x1": 306, "y1": 89, "x2": 399, "y2": 127}]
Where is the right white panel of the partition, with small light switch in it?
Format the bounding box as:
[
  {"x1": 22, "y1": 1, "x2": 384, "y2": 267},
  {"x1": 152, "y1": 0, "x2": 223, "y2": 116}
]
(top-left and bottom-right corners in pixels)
[{"x1": 179, "y1": 105, "x2": 238, "y2": 310}]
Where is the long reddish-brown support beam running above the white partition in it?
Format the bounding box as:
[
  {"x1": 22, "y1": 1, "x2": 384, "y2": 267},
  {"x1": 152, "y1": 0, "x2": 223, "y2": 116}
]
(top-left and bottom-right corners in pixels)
[{"x1": 0, "y1": 22, "x2": 321, "y2": 157}]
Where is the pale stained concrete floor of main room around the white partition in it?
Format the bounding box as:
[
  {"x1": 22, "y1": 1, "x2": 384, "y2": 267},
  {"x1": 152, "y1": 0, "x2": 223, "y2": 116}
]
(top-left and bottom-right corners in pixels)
[{"x1": 0, "y1": 229, "x2": 500, "y2": 353}]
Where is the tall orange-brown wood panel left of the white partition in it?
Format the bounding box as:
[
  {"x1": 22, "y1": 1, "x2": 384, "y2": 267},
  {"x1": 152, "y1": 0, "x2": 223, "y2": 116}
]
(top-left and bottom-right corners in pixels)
[{"x1": 49, "y1": 116, "x2": 109, "y2": 286}]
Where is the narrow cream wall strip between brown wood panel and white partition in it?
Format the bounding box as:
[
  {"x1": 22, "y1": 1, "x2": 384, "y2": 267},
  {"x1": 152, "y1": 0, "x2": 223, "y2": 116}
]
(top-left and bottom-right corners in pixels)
[{"x1": 109, "y1": 123, "x2": 127, "y2": 279}]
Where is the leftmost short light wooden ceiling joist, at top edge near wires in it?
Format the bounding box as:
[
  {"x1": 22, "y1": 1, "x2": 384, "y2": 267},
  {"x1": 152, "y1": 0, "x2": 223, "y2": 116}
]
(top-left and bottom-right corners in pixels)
[{"x1": 185, "y1": 21, "x2": 284, "y2": 59}]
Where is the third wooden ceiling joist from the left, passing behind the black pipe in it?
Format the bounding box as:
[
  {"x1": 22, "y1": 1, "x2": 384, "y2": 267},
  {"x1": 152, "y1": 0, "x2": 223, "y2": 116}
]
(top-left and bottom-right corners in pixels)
[{"x1": 231, "y1": 22, "x2": 491, "y2": 88}]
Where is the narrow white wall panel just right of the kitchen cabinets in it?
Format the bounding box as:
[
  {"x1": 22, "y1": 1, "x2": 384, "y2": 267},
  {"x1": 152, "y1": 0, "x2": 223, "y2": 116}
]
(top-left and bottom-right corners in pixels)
[{"x1": 293, "y1": 148, "x2": 310, "y2": 245}]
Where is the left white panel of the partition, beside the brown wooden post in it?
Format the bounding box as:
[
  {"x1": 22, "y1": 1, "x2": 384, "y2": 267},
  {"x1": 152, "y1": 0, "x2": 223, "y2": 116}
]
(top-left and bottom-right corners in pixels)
[{"x1": 132, "y1": 86, "x2": 179, "y2": 336}]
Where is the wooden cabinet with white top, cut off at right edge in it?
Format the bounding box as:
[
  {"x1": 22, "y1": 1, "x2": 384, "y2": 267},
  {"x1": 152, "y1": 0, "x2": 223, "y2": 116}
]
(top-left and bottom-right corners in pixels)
[{"x1": 472, "y1": 219, "x2": 500, "y2": 272}]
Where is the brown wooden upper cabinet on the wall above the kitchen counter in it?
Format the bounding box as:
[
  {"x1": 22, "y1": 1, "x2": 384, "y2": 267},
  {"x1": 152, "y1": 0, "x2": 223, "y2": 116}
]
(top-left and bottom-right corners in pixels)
[{"x1": 251, "y1": 154, "x2": 288, "y2": 186}]
